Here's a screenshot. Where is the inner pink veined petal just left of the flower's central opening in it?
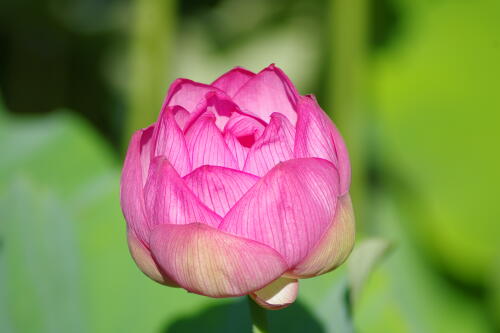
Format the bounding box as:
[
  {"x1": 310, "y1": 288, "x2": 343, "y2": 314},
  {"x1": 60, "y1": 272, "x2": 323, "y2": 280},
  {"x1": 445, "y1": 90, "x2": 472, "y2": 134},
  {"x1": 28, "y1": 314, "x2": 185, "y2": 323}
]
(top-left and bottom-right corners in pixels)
[{"x1": 186, "y1": 113, "x2": 238, "y2": 169}]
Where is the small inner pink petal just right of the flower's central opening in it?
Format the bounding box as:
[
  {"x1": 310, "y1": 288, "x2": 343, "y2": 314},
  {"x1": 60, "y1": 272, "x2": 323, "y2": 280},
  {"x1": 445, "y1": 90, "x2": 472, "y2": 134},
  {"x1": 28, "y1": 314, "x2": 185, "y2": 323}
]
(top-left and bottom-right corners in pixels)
[{"x1": 243, "y1": 113, "x2": 295, "y2": 176}]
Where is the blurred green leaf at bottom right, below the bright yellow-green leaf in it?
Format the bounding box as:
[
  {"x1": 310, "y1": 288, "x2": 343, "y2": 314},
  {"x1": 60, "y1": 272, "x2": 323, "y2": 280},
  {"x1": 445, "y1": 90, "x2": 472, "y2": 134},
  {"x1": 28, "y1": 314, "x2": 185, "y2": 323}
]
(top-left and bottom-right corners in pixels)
[{"x1": 354, "y1": 195, "x2": 493, "y2": 333}]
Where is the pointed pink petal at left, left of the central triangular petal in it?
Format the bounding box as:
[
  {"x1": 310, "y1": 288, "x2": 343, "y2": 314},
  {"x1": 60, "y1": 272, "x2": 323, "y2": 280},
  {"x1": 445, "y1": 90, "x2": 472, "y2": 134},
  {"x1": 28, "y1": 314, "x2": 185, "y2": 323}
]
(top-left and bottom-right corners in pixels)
[{"x1": 144, "y1": 157, "x2": 221, "y2": 227}]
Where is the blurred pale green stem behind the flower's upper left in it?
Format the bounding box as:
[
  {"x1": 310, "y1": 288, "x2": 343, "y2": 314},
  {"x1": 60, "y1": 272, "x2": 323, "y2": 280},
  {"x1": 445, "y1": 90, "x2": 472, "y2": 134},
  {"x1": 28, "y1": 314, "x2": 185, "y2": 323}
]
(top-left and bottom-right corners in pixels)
[{"x1": 124, "y1": 0, "x2": 177, "y2": 148}]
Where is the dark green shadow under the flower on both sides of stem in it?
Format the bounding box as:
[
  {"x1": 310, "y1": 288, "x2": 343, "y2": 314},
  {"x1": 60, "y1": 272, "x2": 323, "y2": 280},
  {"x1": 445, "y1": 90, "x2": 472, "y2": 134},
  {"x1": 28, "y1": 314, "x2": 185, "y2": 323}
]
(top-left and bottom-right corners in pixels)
[{"x1": 162, "y1": 298, "x2": 325, "y2": 333}]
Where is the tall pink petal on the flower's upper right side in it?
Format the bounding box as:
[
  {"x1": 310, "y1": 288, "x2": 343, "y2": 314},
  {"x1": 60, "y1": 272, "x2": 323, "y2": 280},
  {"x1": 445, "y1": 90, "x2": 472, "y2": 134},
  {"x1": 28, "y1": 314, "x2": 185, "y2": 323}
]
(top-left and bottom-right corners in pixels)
[{"x1": 295, "y1": 96, "x2": 351, "y2": 194}]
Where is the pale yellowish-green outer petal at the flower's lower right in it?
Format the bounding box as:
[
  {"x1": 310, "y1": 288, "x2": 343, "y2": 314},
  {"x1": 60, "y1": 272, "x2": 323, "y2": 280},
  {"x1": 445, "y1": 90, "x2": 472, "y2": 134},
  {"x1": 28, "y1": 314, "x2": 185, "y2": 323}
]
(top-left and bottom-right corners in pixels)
[{"x1": 287, "y1": 194, "x2": 355, "y2": 278}]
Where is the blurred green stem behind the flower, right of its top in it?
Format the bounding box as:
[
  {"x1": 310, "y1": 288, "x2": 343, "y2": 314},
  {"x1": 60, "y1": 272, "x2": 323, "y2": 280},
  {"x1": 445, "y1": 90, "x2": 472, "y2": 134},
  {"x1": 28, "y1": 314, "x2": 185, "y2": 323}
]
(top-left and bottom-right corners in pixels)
[{"x1": 328, "y1": 0, "x2": 371, "y2": 231}]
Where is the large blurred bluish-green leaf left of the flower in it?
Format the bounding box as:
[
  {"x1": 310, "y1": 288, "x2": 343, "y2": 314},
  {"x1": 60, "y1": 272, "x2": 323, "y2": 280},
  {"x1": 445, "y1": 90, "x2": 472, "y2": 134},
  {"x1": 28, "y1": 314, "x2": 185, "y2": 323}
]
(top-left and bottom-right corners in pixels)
[{"x1": 0, "y1": 109, "x2": 219, "y2": 332}]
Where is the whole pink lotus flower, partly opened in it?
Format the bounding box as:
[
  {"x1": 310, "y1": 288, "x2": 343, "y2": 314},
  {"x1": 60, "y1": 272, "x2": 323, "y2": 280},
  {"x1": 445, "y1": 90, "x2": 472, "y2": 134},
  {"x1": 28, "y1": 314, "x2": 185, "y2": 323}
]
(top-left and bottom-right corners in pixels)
[{"x1": 121, "y1": 65, "x2": 354, "y2": 309}]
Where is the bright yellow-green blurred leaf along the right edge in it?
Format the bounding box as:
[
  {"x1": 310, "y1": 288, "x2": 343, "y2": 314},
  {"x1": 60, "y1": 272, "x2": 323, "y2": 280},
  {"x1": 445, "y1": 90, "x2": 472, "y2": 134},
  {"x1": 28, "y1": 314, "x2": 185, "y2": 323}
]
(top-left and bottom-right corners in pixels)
[{"x1": 373, "y1": 0, "x2": 500, "y2": 284}]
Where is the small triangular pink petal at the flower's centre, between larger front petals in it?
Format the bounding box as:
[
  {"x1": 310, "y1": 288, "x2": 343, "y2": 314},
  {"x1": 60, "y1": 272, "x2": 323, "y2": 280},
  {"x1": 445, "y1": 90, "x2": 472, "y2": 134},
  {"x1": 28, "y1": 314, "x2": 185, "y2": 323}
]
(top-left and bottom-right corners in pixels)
[{"x1": 184, "y1": 165, "x2": 259, "y2": 216}]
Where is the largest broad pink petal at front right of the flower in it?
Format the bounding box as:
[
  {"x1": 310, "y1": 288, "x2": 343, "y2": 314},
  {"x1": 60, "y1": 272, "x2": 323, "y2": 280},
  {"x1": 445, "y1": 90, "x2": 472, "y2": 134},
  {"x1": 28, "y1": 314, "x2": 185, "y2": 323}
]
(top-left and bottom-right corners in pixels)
[{"x1": 219, "y1": 158, "x2": 338, "y2": 267}]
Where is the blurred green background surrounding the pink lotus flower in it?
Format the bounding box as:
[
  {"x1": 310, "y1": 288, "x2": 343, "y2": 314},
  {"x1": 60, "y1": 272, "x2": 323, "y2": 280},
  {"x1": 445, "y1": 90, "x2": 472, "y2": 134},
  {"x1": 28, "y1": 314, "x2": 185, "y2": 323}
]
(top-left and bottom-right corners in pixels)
[{"x1": 0, "y1": 0, "x2": 500, "y2": 333}]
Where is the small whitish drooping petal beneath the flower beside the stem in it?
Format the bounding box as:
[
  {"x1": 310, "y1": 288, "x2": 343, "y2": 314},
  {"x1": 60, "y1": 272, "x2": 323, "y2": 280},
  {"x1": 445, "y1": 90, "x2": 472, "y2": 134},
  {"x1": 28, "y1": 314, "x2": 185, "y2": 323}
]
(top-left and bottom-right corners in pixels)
[{"x1": 250, "y1": 277, "x2": 299, "y2": 310}]
